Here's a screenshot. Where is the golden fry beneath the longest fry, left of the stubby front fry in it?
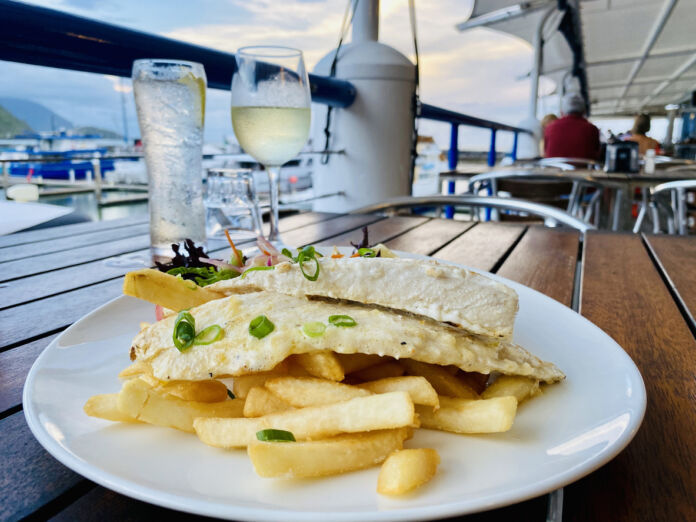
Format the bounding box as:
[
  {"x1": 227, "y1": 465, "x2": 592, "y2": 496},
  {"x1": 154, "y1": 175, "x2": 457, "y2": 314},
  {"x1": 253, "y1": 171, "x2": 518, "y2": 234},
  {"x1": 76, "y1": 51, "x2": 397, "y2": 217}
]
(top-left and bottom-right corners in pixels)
[{"x1": 247, "y1": 428, "x2": 408, "y2": 478}]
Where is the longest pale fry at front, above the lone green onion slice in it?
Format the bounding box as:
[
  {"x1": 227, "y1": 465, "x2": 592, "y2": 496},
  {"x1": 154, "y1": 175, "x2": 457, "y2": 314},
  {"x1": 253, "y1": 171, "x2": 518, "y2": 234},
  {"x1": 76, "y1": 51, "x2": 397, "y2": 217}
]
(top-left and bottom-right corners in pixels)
[{"x1": 193, "y1": 392, "x2": 415, "y2": 448}]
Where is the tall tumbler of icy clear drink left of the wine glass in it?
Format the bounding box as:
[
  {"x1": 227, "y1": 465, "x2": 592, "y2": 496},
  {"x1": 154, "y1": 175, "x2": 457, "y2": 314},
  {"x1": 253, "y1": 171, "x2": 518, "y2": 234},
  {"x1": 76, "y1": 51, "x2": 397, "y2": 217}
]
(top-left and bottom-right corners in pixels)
[{"x1": 133, "y1": 59, "x2": 206, "y2": 261}]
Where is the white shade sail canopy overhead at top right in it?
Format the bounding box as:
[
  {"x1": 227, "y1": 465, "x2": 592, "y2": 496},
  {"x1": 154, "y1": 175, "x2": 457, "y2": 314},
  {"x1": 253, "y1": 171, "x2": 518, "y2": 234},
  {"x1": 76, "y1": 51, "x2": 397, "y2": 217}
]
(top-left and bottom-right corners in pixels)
[{"x1": 462, "y1": 0, "x2": 696, "y2": 116}]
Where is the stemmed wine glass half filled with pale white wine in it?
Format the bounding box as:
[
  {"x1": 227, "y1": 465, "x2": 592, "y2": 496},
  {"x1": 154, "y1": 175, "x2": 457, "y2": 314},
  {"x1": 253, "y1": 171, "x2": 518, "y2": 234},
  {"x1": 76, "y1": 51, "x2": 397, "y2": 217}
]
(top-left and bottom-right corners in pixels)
[{"x1": 232, "y1": 46, "x2": 311, "y2": 241}]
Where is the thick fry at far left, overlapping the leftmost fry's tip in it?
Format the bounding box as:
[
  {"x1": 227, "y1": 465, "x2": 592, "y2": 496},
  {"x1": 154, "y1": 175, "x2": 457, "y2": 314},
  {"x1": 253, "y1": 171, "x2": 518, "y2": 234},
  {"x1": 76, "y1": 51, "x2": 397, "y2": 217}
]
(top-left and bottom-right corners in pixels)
[{"x1": 118, "y1": 379, "x2": 244, "y2": 432}]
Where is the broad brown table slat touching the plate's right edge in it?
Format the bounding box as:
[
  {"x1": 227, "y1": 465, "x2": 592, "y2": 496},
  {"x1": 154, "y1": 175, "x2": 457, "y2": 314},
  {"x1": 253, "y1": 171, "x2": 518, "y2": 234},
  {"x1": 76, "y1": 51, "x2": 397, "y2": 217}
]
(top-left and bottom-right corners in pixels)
[{"x1": 563, "y1": 233, "x2": 696, "y2": 522}]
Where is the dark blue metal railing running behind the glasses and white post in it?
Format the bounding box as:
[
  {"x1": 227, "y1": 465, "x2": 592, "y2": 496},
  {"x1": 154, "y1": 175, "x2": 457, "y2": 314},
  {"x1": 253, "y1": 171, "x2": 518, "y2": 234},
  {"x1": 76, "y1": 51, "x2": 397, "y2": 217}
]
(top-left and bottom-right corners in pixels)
[{"x1": 0, "y1": 0, "x2": 529, "y2": 214}]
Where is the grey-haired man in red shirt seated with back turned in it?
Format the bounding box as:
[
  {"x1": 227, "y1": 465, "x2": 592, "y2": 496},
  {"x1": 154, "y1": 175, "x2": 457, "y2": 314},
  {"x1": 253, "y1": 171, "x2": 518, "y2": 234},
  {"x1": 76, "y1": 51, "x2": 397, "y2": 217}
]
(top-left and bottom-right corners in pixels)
[{"x1": 544, "y1": 93, "x2": 600, "y2": 160}]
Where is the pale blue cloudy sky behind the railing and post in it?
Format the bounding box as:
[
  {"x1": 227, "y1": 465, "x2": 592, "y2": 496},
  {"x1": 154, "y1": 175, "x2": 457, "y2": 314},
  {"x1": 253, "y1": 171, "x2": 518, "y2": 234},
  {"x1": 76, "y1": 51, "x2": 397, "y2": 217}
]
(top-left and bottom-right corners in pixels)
[{"x1": 0, "y1": 0, "x2": 662, "y2": 150}]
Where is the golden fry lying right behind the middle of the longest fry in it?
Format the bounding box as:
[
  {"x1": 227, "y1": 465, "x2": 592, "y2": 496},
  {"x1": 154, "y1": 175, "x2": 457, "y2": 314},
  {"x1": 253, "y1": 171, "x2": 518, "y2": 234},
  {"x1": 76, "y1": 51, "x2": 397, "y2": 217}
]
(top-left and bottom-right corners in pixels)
[{"x1": 264, "y1": 377, "x2": 370, "y2": 408}]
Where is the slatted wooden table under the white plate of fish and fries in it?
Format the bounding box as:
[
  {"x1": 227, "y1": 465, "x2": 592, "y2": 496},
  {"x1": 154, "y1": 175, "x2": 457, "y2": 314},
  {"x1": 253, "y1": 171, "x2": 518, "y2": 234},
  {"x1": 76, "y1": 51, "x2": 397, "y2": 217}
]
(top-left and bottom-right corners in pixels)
[{"x1": 0, "y1": 213, "x2": 696, "y2": 522}]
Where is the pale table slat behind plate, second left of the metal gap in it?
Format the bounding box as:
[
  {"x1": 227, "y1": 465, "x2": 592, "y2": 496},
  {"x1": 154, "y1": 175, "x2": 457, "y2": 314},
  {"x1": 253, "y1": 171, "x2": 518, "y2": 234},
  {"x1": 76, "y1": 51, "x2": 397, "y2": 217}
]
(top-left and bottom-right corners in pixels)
[{"x1": 433, "y1": 223, "x2": 526, "y2": 272}]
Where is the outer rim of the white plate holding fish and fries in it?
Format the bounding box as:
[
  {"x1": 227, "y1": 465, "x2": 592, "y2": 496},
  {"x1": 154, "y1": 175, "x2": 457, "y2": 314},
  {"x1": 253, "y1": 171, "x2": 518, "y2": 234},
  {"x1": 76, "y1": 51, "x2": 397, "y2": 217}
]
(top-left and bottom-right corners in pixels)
[{"x1": 22, "y1": 247, "x2": 647, "y2": 522}]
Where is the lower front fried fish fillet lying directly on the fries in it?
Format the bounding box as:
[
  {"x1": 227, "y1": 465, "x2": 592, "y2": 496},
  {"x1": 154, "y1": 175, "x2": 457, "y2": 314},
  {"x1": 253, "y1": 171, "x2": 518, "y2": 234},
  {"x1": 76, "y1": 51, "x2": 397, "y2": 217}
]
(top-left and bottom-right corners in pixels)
[{"x1": 131, "y1": 291, "x2": 564, "y2": 382}]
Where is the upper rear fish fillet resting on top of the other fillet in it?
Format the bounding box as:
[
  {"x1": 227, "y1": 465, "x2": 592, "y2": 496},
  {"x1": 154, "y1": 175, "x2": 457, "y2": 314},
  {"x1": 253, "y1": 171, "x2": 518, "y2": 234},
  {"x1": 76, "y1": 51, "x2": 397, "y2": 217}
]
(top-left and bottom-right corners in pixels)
[{"x1": 208, "y1": 258, "x2": 518, "y2": 339}]
